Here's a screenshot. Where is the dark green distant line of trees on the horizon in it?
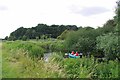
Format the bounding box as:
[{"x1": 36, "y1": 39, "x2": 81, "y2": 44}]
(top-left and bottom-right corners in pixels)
[{"x1": 8, "y1": 24, "x2": 78, "y2": 40}]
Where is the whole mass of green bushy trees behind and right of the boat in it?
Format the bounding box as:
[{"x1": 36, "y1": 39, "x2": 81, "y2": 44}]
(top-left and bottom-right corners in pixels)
[{"x1": 64, "y1": 19, "x2": 119, "y2": 59}]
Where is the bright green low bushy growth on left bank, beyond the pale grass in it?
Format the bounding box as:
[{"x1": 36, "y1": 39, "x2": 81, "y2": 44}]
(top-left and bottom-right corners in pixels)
[{"x1": 6, "y1": 41, "x2": 45, "y2": 58}]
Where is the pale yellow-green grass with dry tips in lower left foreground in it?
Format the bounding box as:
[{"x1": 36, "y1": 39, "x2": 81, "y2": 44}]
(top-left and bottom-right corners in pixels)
[{"x1": 2, "y1": 42, "x2": 65, "y2": 78}]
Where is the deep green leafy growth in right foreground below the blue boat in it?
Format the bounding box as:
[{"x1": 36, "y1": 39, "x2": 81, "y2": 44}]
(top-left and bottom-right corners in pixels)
[{"x1": 63, "y1": 57, "x2": 118, "y2": 79}]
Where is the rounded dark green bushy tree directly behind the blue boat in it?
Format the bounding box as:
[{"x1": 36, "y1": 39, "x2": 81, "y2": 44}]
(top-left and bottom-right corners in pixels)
[{"x1": 65, "y1": 27, "x2": 97, "y2": 53}]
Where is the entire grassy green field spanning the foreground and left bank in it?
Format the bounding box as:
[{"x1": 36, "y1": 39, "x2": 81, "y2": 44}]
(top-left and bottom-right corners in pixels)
[{"x1": 0, "y1": 40, "x2": 118, "y2": 79}]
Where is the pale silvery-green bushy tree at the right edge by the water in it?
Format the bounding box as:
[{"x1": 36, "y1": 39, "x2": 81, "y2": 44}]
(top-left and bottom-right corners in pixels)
[{"x1": 96, "y1": 33, "x2": 120, "y2": 59}]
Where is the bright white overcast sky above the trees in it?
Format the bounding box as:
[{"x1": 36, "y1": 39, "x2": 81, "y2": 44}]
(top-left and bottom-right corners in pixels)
[{"x1": 0, "y1": 0, "x2": 117, "y2": 38}]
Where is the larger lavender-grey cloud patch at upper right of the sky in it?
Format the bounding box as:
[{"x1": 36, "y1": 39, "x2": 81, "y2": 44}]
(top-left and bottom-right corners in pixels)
[{"x1": 71, "y1": 6, "x2": 109, "y2": 16}]
